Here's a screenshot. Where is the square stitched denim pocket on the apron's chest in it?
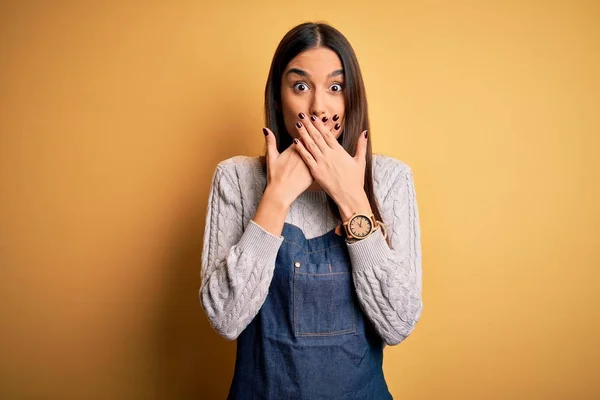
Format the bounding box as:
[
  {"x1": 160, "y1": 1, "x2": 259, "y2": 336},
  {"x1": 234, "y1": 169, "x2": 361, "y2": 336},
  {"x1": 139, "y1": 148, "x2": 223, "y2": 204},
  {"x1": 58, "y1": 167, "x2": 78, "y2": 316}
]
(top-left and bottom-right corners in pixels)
[{"x1": 293, "y1": 263, "x2": 356, "y2": 336}]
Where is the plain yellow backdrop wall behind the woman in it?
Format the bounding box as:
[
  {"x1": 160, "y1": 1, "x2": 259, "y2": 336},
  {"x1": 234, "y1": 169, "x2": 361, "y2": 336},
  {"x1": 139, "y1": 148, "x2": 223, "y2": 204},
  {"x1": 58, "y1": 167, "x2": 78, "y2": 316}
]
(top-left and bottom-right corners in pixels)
[{"x1": 0, "y1": 0, "x2": 600, "y2": 399}]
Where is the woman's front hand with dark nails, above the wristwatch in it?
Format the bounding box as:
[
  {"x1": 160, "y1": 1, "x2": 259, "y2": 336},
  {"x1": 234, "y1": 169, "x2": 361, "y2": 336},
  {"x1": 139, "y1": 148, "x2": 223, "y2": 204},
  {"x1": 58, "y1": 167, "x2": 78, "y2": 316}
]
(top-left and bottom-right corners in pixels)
[{"x1": 294, "y1": 114, "x2": 371, "y2": 220}]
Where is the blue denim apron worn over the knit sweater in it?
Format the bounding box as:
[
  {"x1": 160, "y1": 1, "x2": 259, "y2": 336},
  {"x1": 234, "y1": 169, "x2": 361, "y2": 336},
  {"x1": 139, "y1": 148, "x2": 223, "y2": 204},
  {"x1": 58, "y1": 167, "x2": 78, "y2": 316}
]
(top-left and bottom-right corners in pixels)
[{"x1": 227, "y1": 222, "x2": 392, "y2": 400}]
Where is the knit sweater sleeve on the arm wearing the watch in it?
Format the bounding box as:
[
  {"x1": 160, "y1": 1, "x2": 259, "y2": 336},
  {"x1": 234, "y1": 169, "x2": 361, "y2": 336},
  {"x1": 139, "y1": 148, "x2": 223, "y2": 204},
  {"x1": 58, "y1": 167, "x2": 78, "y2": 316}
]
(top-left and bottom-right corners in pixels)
[{"x1": 348, "y1": 165, "x2": 423, "y2": 345}]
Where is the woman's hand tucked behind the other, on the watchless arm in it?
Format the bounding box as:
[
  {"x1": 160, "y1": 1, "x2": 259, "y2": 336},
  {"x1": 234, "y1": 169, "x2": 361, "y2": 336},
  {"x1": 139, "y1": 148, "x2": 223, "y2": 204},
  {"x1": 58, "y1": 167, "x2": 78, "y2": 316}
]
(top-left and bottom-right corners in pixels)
[{"x1": 265, "y1": 128, "x2": 314, "y2": 207}]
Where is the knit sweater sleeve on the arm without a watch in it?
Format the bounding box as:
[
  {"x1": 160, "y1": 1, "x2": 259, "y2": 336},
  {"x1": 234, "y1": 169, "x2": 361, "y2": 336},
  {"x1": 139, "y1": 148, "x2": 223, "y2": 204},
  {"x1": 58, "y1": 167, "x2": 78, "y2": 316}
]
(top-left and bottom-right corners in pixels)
[{"x1": 199, "y1": 163, "x2": 283, "y2": 340}]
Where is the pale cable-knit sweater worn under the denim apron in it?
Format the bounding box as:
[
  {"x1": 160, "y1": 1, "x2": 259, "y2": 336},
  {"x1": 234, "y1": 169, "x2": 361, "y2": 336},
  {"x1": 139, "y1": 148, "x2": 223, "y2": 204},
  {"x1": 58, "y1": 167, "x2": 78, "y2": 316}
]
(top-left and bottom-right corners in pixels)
[{"x1": 199, "y1": 154, "x2": 423, "y2": 345}]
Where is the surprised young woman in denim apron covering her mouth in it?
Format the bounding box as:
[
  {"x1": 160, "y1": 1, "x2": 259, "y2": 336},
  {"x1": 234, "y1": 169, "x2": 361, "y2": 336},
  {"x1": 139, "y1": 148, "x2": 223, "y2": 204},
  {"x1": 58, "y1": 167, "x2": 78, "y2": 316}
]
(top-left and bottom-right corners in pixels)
[{"x1": 200, "y1": 23, "x2": 423, "y2": 400}]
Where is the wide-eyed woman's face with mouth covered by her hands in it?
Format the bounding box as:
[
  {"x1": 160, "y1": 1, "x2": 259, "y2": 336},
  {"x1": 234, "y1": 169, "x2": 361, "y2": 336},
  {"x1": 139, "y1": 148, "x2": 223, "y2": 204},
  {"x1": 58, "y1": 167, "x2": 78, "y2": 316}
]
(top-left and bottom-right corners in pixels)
[{"x1": 281, "y1": 47, "x2": 344, "y2": 138}]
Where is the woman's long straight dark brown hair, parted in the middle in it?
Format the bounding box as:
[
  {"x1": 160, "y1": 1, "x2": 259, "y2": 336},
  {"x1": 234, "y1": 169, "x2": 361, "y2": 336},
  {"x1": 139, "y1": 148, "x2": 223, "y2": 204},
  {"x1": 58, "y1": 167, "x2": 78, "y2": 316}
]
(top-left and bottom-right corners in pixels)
[{"x1": 261, "y1": 22, "x2": 385, "y2": 231}]
